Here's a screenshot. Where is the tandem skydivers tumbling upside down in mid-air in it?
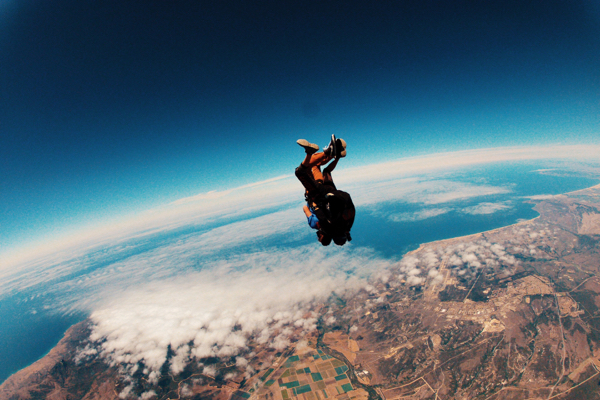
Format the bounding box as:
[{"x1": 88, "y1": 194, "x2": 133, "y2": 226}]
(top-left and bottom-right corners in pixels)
[{"x1": 296, "y1": 135, "x2": 355, "y2": 246}]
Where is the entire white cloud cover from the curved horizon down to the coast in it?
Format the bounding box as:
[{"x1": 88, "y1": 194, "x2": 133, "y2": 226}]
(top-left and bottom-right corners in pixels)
[{"x1": 0, "y1": 147, "x2": 600, "y2": 390}]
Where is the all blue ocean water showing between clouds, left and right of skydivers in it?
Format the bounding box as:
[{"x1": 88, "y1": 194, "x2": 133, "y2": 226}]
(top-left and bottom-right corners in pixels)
[{"x1": 0, "y1": 163, "x2": 598, "y2": 382}]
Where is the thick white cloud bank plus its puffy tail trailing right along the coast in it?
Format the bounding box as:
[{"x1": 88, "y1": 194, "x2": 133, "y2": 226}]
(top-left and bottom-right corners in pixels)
[{"x1": 80, "y1": 216, "x2": 558, "y2": 388}]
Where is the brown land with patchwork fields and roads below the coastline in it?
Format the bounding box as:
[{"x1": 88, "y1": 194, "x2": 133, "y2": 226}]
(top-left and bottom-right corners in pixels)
[{"x1": 0, "y1": 185, "x2": 600, "y2": 400}]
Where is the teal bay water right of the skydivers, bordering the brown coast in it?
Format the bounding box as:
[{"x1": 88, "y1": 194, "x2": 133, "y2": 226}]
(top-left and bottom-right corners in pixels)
[{"x1": 352, "y1": 164, "x2": 599, "y2": 257}]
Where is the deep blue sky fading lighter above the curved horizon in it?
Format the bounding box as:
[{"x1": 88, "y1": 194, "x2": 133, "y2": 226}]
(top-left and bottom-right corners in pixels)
[{"x1": 0, "y1": 0, "x2": 600, "y2": 247}]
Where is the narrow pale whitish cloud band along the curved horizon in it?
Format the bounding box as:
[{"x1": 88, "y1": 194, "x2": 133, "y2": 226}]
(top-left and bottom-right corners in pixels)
[{"x1": 5, "y1": 145, "x2": 600, "y2": 268}]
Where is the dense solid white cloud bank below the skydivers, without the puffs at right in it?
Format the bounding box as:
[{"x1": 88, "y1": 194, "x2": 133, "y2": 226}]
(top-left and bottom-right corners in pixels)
[{"x1": 76, "y1": 246, "x2": 390, "y2": 380}]
